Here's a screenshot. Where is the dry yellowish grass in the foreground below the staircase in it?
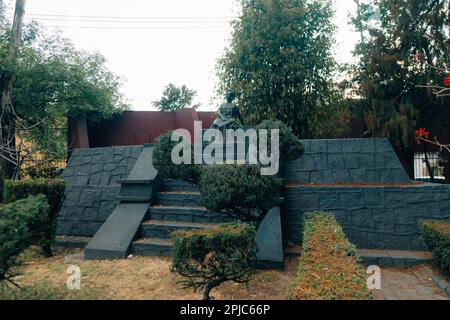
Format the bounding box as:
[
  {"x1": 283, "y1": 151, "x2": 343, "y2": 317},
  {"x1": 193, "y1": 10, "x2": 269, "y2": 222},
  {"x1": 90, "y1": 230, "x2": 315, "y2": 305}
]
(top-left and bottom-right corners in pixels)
[{"x1": 0, "y1": 250, "x2": 298, "y2": 300}]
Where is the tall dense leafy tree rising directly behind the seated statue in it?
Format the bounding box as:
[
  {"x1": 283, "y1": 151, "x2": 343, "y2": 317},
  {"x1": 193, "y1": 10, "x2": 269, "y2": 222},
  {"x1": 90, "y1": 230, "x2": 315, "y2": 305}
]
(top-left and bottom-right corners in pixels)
[{"x1": 217, "y1": 0, "x2": 346, "y2": 138}]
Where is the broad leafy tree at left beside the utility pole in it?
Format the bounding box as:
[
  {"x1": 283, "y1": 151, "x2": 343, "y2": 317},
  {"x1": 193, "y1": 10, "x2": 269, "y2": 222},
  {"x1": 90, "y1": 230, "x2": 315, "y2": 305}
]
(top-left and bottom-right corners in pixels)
[{"x1": 0, "y1": 11, "x2": 127, "y2": 182}]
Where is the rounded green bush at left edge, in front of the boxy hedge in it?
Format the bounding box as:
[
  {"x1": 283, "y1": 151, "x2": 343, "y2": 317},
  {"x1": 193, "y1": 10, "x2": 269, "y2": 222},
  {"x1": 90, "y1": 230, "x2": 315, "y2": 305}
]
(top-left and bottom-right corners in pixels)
[{"x1": 0, "y1": 195, "x2": 50, "y2": 284}]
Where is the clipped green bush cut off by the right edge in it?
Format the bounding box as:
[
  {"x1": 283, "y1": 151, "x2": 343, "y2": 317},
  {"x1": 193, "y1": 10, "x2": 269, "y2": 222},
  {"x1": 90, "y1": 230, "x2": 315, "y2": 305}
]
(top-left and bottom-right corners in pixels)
[{"x1": 420, "y1": 220, "x2": 450, "y2": 275}]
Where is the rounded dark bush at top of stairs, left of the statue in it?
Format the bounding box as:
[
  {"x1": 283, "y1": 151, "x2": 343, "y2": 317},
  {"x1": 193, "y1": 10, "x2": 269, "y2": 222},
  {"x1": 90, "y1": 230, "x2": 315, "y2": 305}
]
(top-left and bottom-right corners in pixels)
[{"x1": 153, "y1": 131, "x2": 201, "y2": 183}]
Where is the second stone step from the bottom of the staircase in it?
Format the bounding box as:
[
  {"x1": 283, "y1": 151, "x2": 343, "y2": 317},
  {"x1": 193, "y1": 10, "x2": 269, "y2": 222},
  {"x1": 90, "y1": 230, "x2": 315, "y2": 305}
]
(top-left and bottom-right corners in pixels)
[{"x1": 139, "y1": 220, "x2": 215, "y2": 239}]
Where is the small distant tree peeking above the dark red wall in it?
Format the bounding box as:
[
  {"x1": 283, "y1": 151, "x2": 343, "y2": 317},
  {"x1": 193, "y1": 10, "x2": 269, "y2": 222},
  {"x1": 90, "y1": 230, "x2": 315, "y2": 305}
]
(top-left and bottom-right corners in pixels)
[{"x1": 152, "y1": 83, "x2": 197, "y2": 111}]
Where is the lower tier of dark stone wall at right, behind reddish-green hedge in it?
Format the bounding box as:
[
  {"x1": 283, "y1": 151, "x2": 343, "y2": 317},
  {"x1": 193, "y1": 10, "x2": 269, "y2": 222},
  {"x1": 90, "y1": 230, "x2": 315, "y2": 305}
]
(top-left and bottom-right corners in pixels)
[{"x1": 282, "y1": 184, "x2": 450, "y2": 250}]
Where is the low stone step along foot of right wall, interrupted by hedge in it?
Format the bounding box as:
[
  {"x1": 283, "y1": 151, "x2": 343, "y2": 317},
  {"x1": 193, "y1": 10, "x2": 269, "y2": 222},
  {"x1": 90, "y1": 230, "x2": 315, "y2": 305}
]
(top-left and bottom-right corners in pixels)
[{"x1": 284, "y1": 246, "x2": 433, "y2": 268}]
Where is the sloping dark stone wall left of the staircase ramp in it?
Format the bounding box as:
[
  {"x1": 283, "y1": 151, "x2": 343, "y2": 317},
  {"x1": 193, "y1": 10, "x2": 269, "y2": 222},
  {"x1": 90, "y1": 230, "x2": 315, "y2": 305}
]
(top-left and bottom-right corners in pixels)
[{"x1": 56, "y1": 146, "x2": 142, "y2": 236}]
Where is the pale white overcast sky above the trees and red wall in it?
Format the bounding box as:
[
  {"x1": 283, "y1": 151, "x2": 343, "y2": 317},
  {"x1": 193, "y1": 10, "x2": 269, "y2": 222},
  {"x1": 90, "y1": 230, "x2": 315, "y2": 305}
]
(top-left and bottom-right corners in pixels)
[{"x1": 2, "y1": 0, "x2": 357, "y2": 110}]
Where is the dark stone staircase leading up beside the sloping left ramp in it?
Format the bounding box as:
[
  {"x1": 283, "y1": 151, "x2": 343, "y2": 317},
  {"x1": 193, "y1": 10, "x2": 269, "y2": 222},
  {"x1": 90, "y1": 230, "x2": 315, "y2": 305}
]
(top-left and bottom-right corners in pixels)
[{"x1": 130, "y1": 179, "x2": 233, "y2": 256}]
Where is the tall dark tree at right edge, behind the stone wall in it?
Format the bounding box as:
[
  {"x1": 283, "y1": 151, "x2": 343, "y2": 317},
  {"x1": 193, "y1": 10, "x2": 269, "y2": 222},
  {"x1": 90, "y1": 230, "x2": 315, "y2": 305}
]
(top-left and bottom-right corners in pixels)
[{"x1": 353, "y1": 0, "x2": 450, "y2": 152}]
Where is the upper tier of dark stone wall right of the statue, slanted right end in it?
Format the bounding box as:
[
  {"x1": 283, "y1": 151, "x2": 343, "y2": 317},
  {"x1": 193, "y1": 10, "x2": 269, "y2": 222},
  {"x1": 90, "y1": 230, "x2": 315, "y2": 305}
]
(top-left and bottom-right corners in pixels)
[{"x1": 284, "y1": 139, "x2": 409, "y2": 183}]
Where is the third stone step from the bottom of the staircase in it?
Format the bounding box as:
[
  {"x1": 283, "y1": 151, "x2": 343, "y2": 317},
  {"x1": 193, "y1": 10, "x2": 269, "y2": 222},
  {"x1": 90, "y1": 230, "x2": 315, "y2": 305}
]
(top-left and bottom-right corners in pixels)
[{"x1": 146, "y1": 205, "x2": 234, "y2": 223}]
